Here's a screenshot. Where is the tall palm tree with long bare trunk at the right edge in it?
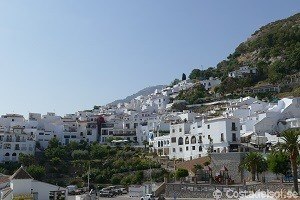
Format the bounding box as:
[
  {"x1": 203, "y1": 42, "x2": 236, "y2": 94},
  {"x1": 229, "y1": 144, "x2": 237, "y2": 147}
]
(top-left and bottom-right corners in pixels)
[{"x1": 279, "y1": 129, "x2": 300, "y2": 194}]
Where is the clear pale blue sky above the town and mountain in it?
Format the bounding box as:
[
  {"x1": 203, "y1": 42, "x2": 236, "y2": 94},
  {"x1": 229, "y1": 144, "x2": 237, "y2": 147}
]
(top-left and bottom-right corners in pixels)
[{"x1": 0, "y1": 0, "x2": 300, "y2": 116}]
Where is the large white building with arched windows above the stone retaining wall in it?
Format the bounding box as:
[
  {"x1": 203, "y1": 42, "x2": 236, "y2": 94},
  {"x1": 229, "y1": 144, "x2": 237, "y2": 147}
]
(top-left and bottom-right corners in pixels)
[{"x1": 151, "y1": 115, "x2": 240, "y2": 160}]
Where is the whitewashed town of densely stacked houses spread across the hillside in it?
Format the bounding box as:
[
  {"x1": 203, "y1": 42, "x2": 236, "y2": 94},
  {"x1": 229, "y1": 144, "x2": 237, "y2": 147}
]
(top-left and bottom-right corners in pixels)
[{"x1": 0, "y1": 72, "x2": 300, "y2": 199}]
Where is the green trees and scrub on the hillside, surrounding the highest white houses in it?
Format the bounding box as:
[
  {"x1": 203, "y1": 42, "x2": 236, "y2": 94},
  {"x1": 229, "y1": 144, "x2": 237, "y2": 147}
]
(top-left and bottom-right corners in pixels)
[{"x1": 183, "y1": 13, "x2": 300, "y2": 99}]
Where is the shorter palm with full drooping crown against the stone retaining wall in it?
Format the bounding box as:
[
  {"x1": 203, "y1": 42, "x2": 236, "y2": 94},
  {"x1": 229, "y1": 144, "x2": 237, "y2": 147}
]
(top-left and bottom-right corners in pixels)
[{"x1": 240, "y1": 152, "x2": 264, "y2": 181}]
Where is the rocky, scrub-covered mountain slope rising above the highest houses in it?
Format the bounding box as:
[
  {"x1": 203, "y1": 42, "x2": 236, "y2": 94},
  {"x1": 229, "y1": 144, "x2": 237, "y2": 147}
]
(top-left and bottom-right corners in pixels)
[{"x1": 217, "y1": 13, "x2": 300, "y2": 83}]
